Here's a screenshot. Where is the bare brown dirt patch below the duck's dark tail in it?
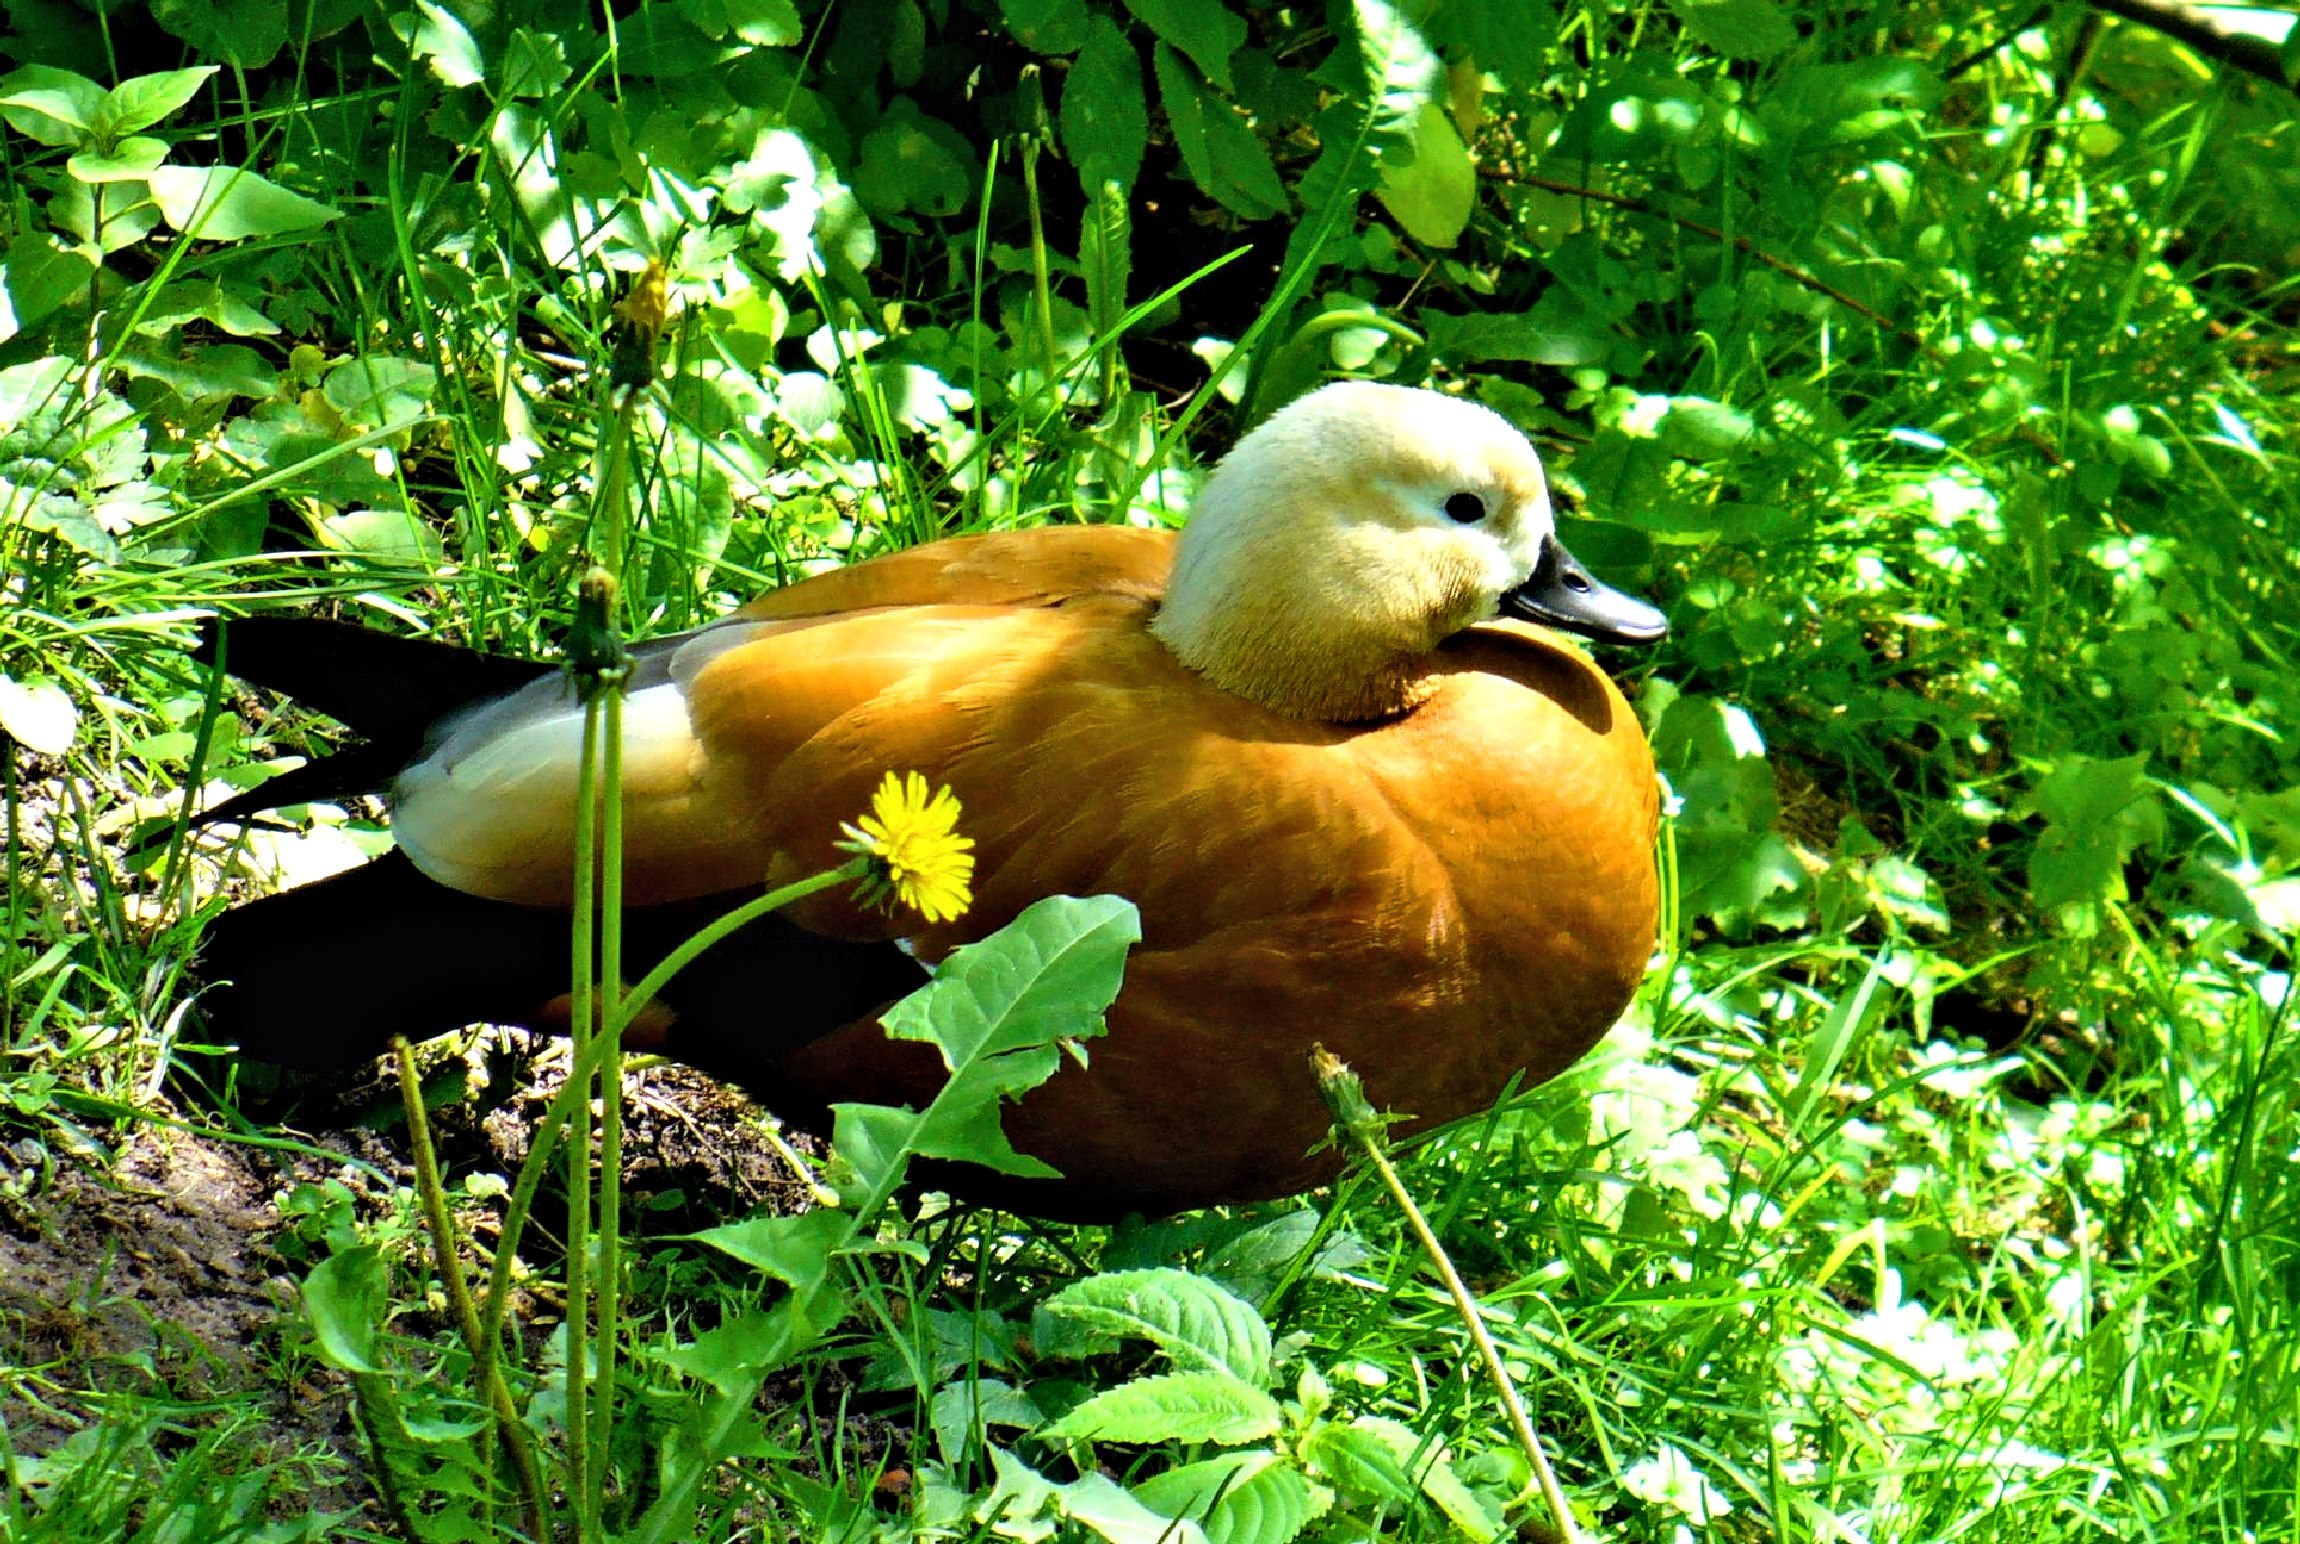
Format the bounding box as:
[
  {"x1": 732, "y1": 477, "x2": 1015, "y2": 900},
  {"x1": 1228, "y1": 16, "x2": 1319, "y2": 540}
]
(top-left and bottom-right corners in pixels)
[{"x1": 0, "y1": 1040, "x2": 823, "y2": 1523}]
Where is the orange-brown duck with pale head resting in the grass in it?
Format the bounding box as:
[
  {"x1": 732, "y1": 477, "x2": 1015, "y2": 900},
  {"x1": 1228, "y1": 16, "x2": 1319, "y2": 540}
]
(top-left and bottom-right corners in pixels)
[{"x1": 200, "y1": 382, "x2": 1668, "y2": 1222}]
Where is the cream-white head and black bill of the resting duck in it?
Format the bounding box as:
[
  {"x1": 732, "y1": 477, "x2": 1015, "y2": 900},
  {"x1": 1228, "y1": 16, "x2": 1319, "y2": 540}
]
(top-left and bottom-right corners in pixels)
[{"x1": 1150, "y1": 382, "x2": 1668, "y2": 723}]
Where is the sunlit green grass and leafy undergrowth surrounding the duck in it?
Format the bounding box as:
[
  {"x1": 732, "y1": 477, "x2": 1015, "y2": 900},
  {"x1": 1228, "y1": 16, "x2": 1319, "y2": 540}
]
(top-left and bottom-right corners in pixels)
[{"x1": 0, "y1": 5, "x2": 2300, "y2": 1544}]
